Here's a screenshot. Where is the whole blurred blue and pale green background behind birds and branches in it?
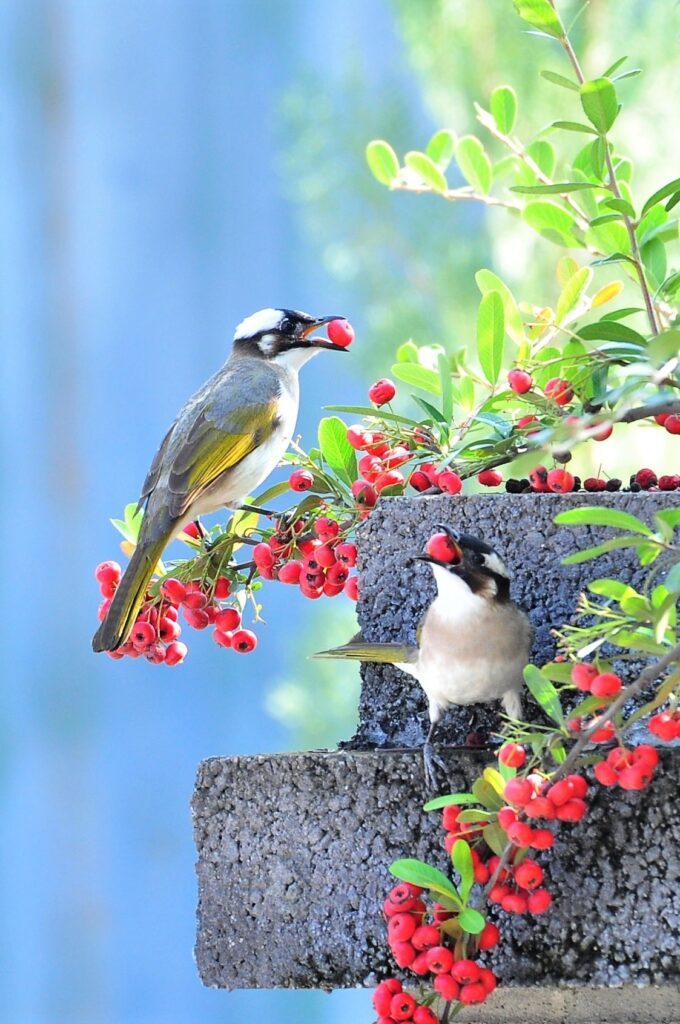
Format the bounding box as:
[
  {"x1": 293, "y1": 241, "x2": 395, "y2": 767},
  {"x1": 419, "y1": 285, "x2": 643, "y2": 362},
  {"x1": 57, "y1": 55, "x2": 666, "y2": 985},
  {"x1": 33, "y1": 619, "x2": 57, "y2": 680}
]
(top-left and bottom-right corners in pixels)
[{"x1": 0, "y1": 0, "x2": 680, "y2": 1024}]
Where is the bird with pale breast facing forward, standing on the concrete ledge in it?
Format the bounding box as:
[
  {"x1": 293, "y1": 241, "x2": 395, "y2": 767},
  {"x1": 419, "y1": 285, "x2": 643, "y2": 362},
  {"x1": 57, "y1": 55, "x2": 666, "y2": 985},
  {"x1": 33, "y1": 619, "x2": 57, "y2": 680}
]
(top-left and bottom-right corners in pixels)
[{"x1": 314, "y1": 524, "x2": 534, "y2": 788}]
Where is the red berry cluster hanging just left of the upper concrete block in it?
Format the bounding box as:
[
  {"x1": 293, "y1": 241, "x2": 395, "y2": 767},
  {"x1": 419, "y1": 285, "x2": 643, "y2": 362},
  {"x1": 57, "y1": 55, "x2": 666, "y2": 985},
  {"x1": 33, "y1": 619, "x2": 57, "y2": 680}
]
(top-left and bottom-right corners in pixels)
[{"x1": 253, "y1": 516, "x2": 358, "y2": 601}]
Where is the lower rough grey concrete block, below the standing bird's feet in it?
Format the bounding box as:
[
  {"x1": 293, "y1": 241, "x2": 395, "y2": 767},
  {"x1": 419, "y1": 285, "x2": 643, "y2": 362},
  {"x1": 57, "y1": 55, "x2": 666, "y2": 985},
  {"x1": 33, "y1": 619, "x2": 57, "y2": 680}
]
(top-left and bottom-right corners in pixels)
[{"x1": 194, "y1": 751, "x2": 680, "y2": 991}]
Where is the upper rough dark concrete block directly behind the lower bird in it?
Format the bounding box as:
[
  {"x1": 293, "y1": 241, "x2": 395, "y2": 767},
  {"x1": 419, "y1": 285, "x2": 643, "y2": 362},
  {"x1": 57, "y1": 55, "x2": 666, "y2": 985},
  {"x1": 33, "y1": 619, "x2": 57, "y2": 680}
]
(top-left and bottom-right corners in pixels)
[{"x1": 349, "y1": 492, "x2": 678, "y2": 748}]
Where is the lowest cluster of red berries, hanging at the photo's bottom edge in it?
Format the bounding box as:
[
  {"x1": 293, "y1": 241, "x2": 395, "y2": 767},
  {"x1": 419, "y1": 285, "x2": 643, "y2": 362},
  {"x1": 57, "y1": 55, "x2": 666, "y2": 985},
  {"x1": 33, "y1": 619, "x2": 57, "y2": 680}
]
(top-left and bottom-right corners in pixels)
[{"x1": 383, "y1": 882, "x2": 500, "y2": 1020}]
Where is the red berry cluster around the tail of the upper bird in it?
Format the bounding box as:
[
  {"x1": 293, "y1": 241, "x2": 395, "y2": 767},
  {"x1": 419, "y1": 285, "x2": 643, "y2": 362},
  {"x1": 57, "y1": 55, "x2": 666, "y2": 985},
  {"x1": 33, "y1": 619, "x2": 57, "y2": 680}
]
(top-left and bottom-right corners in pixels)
[{"x1": 94, "y1": 561, "x2": 257, "y2": 666}]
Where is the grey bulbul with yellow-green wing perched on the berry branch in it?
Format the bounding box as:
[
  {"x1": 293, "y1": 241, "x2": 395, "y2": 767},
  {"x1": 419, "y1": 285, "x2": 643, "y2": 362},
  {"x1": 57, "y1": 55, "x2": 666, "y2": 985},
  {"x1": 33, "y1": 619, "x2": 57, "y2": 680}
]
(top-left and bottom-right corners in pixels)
[{"x1": 92, "y1": 309, "x2": 346, "y2": 651}]
